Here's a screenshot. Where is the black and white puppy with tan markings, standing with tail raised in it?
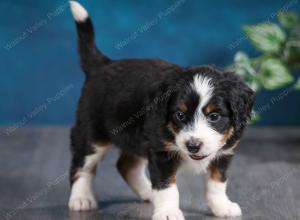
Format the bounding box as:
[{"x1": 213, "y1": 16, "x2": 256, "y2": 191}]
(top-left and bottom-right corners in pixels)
[{"x1": 69, "y1": 1, "x2": 254, "y2": 220}]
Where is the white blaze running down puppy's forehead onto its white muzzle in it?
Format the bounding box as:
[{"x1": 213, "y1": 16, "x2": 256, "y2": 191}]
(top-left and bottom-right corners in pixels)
[{"x1": 175, "y1": 74, "x2": 222, "y2": 158}]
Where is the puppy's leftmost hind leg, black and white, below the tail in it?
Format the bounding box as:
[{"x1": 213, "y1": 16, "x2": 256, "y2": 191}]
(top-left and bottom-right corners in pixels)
[{"x1": 69, "y1": 126, "x2": 111, "y2": 211}]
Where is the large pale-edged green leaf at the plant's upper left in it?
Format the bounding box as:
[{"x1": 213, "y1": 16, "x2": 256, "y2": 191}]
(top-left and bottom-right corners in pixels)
[{"x1": 243, "y1": 23, "x2": 286, "y2": 53}]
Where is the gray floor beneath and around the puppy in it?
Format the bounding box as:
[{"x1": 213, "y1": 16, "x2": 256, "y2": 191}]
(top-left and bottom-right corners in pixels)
[{"x1": 0, "y1": 127, "x2": 300, "y2": 220}]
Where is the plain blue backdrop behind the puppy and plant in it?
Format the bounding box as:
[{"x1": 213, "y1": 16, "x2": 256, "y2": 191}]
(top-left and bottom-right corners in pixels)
[{"x1": 0, "y1": 0, "x2": 300, "y2": 127}]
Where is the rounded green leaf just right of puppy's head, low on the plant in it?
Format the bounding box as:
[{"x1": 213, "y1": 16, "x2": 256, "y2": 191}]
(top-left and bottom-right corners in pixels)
[{"x1": 258, "y1": 58, "x2": 293, "y2": 89}]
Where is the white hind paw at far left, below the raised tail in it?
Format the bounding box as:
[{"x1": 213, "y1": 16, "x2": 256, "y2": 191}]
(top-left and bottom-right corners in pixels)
[{"x1": 69, "y1": 196, "x2": 97, "y2": 211}]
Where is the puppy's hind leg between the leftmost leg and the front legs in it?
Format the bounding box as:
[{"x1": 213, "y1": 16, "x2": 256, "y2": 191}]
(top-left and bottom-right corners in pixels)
[{"x1": 117, "y1": 153, "x2": 152, "y2": 201}]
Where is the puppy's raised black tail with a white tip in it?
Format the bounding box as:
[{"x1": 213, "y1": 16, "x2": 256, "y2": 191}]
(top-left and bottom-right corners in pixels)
[{"x1": 70, "y1": 1, "x2": 110, "y2": 76}]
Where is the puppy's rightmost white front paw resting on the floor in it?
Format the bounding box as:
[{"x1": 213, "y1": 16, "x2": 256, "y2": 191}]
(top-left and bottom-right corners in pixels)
[{"x1": 209, "y1": 199, "x2": 242, "y2": 218}]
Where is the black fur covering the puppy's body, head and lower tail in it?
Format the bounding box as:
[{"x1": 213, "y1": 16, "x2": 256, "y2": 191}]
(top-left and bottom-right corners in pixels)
[{"x1": 71, "y1": 11, "x2": 254, "y2": 189}]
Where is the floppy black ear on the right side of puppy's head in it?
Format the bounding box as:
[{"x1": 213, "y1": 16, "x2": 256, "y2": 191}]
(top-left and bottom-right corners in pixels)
[{"x1": 222, "y1": 73, "x2": 255, "y2": 148}]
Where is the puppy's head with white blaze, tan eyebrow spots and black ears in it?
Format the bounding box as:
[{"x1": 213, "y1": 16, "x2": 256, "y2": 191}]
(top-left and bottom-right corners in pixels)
[{"x1": 167, "y1": 68, "x2": 254, "y2": 160}]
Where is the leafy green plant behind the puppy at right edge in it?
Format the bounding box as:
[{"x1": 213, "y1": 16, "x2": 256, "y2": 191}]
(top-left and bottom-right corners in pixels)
[{"x1": 228, "y1": 12, "x2": 300, "y2": 120}]
